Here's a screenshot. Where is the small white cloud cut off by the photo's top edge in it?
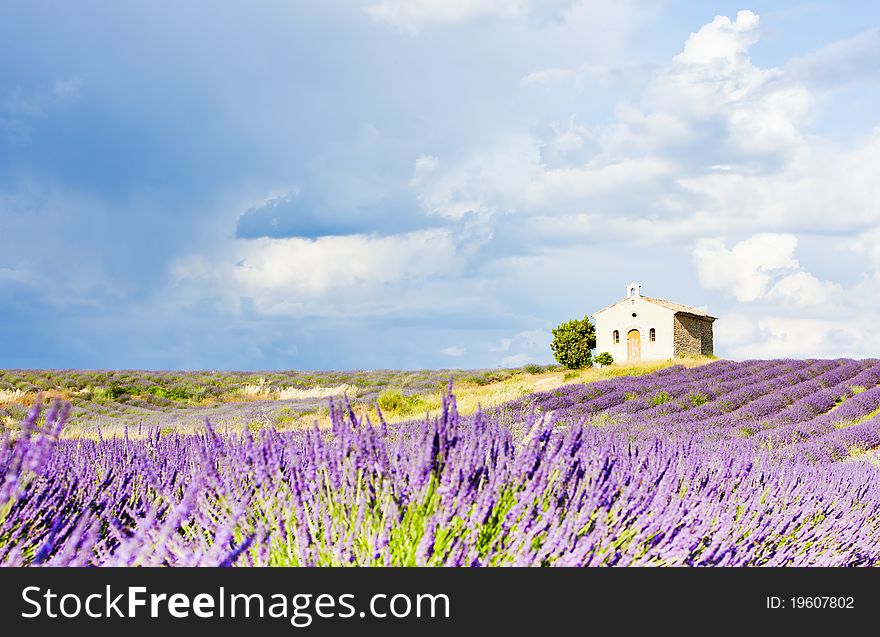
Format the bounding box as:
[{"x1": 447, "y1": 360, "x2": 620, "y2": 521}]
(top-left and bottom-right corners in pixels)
[{"x1": 366, "y1": 0, "x2": 530, "y2": 33}]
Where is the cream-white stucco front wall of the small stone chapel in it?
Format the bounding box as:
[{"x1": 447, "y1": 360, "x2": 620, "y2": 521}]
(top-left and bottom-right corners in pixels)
[{"x1": 593, "y1": 296, "x2": 675, "y2": 363}]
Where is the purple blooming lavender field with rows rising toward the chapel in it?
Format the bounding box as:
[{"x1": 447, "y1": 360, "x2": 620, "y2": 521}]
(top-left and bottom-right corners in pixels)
[{"x1": 0, "y1": 359, "x2": 880, "y2": 566}]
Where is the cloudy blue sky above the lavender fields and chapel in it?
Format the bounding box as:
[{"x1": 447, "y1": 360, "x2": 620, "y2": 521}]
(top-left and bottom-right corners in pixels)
[{"x1": 0, "y1": 0, "x2": 880, "y2": 370}]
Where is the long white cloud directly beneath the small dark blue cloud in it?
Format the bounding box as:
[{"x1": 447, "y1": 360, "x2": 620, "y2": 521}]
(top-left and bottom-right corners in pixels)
[{"x1": 171, "y1": 230, "x2": 460, "y2": 316}]
